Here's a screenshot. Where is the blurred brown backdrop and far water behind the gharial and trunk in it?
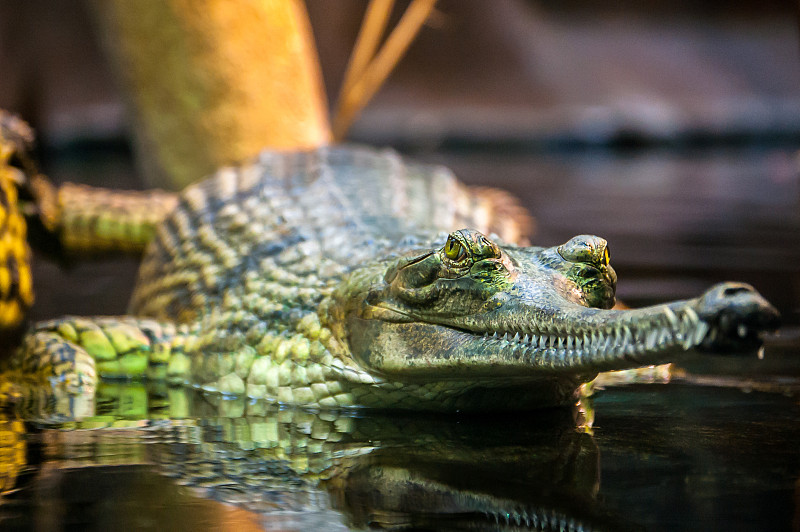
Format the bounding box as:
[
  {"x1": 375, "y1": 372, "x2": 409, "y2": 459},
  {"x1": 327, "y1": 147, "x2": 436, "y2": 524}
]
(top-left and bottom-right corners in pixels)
[{"x1": 0, "y1": 0, "x2": 800, "y2": 324}]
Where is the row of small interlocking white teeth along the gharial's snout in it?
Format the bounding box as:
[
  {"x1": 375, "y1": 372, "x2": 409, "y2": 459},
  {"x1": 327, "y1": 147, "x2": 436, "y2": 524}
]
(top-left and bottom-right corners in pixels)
[{"x1": 484, "y1": 307, "x2": 709, "y2": 357}]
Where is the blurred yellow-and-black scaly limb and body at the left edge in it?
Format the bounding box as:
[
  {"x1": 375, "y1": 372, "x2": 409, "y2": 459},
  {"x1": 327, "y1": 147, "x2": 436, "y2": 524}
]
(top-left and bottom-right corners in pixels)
[{"x1": 0, "y1": 109, "x2": 169, "y2": 336}]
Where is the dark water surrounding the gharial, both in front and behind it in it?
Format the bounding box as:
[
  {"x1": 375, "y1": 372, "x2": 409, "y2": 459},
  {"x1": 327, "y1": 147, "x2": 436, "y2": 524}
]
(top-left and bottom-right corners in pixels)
[{"x1": 0, "y1": 143, "x2": 800, "y2": 530}]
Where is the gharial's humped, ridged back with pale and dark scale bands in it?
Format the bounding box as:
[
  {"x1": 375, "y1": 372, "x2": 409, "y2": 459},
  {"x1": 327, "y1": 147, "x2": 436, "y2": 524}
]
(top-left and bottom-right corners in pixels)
[{"x1": 131, "y1": 147, "x2": 525, "y2": 321}]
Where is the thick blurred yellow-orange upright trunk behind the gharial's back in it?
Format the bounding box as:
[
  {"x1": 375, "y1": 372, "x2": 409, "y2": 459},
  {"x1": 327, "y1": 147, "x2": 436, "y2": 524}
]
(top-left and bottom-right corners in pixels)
[{"x1": 92, "y1": 0, "x2": 331, "y2": 188}]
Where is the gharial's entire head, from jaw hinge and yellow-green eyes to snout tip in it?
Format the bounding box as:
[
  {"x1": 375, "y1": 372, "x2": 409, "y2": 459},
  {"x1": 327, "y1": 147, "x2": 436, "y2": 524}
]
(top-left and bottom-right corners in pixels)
[{"x1": 344, "y1": 230, "x2": 778, "y2": 386}]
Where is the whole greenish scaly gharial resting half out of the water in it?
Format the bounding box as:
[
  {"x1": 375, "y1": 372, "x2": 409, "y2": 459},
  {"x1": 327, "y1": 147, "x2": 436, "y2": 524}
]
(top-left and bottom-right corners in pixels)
[{"x1": 0, "y1": 120, "x2": 778, "y2": 410}]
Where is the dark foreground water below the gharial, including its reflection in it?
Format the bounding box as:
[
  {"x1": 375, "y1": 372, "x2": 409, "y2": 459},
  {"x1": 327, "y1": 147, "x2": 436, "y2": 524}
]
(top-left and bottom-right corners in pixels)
[{"x1": 0, "y1": 383, "x2": 800, "y2": 530}]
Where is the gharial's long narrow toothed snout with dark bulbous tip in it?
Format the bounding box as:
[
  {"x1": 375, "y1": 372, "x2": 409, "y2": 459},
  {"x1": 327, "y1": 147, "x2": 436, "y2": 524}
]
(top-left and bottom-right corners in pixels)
[{"x1": 440, "y1": 283, "x2": 779, "y2": 373}]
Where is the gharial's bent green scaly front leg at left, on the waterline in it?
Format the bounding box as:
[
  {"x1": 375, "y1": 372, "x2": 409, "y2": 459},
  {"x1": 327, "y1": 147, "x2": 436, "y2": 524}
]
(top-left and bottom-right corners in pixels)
[{"x1": 10, "y1": 317, "x2": 189, "y2": 394}]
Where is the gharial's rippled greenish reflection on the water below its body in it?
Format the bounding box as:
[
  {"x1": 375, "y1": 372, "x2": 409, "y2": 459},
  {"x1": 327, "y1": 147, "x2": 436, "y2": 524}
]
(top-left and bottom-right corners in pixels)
[{"x1": 0, "y1": 385, "x2": 640, "y2": 530}]
